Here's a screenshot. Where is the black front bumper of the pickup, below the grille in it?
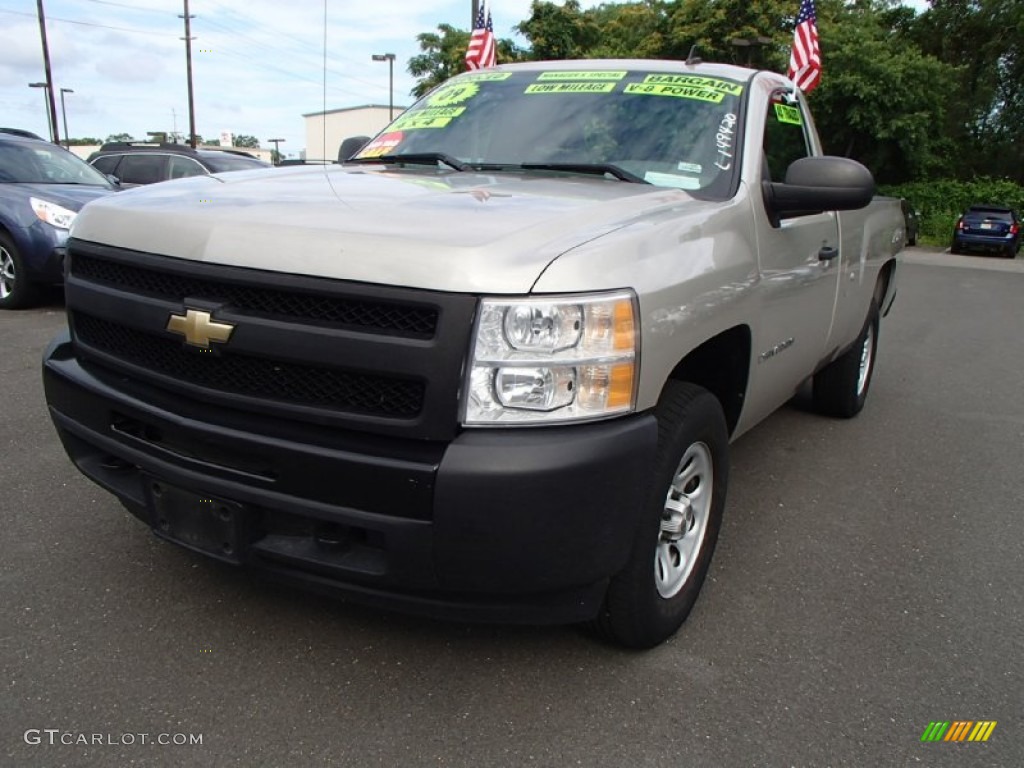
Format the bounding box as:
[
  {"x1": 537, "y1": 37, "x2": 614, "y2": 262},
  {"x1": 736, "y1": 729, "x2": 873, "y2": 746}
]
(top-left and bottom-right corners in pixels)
[{"x1": 43, "y1": 335, "x2": 657, "y2": 623}]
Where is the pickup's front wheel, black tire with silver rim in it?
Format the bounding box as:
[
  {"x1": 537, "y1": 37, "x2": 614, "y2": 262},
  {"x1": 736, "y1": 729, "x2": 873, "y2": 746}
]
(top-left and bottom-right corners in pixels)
[{"x1": 594, "y1": 382, "x2": 729, "y2": 648}]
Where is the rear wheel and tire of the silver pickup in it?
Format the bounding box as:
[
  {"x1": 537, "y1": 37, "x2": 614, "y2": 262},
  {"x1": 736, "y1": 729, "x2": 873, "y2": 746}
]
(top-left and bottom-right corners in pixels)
[{"x1": 814, "y1": 299, "x2": 879, "y2": 419}]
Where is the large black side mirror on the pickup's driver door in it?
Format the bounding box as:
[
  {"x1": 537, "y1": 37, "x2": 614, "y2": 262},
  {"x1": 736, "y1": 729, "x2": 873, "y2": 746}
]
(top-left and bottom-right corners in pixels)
[{"x1": 761, "y1": 157, "x2": 874, "y2": 226}]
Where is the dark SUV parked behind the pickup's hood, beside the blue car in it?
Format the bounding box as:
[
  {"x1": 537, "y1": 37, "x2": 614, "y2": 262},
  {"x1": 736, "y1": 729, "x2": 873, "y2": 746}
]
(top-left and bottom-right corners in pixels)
[{"x1": 89, "y1": 143, "x2": 270, "y2": 186}]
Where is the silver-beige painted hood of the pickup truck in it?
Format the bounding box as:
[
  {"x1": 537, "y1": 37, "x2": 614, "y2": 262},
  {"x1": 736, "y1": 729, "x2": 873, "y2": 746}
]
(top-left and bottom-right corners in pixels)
[{"x1": 72, "y1": 166, "x2": 708, "y2": 294}]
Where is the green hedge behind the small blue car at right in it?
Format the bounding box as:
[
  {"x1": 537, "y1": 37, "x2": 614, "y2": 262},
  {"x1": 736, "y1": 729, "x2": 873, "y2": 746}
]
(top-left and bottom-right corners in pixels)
[{"x1": 879, "y1": 178, "x2": 1024, "y2": 246}]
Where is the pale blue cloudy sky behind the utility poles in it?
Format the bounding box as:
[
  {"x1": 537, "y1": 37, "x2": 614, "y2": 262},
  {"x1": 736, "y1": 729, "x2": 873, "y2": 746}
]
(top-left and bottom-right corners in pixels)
[{"x1": 0, "y1": 0, "x2": 924, "y2": 156}]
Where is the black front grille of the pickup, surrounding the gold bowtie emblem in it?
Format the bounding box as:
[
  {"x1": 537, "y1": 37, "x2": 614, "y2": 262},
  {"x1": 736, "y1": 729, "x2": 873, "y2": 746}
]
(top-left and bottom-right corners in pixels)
[{"x1": 65, "y1": 239, "x2": 476, "y2": 440}]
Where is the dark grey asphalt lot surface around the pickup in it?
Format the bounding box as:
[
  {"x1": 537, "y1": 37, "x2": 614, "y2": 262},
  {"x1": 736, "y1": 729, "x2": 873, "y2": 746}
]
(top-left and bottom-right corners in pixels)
[{"x1": 0, "y1": 249, "x2": 1024, "y2": 767}]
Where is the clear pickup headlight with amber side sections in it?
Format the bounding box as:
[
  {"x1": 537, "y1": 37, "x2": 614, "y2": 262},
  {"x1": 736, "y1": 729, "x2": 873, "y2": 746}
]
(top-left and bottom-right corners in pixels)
[{"x1": 463, "y1": 291, "x2": 639, "y2": 426}]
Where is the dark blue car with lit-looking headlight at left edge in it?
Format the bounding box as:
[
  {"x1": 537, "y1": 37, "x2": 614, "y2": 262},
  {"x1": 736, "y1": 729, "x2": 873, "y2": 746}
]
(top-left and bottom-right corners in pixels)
[{"x1": 0, "y1": 132, "x2": 118, "y2": 309}]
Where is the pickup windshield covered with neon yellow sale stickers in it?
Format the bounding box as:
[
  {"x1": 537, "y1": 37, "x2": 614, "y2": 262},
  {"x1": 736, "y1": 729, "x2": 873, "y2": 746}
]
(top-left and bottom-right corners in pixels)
[{"x1": 355, "y1": 70, "x2": 743, "y2": 197}]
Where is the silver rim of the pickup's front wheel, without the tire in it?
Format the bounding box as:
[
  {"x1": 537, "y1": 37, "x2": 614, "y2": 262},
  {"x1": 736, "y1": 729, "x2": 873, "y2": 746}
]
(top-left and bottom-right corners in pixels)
[{"x1": 654, "y1": 442, "x2": 715, "y2": 599}]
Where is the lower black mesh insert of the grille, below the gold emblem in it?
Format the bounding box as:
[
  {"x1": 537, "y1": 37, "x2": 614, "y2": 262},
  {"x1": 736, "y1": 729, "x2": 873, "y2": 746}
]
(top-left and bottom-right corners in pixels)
[{"x1": 72, "y1": 312, "x2": 424, "y2": 419}]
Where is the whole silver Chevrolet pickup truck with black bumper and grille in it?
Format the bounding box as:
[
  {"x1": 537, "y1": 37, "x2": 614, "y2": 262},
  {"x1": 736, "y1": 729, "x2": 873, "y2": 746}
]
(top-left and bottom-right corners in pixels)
[{"x1": 43, "y1": 60, "x2": 903, "y2": 647}]
